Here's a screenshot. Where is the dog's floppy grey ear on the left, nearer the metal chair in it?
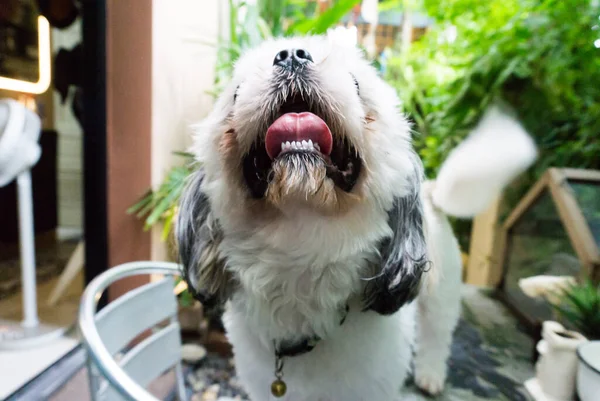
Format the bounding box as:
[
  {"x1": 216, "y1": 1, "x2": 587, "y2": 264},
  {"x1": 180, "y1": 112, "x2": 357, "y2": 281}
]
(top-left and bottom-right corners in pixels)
[{"x1": 176, "y1": 169, "x2": 231, "y2": 307}]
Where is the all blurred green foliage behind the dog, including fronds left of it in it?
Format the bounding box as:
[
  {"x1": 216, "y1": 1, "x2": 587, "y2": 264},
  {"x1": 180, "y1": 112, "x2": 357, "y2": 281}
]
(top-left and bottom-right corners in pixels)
[{"x1": 130, "y1": 0, "x2": 600, "y2": 249}]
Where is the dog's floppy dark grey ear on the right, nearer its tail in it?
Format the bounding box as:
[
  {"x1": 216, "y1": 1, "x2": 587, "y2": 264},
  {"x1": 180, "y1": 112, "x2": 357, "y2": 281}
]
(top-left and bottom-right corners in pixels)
[{"x1": 365, "y1": 155, "x2": 428, "y2": 315}]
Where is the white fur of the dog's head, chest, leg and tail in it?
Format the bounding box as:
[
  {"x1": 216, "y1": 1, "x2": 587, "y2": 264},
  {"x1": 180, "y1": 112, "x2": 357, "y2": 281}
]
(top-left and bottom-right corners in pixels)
[{"x1": 178, "y1": 37, "x2": 531, "y2": 401}]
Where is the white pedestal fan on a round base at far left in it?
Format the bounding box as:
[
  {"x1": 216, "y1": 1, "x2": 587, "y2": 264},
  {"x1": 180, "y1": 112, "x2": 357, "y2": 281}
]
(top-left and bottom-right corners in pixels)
[{"x1": 0, "y1": 99, "x2": 65, "y2": 349}]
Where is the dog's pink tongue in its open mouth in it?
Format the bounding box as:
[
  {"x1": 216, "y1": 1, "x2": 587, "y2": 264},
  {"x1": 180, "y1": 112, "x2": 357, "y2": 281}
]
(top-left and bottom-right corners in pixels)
[{"x1": 265, "y1": 112, "x2": 333, "y2": 159}]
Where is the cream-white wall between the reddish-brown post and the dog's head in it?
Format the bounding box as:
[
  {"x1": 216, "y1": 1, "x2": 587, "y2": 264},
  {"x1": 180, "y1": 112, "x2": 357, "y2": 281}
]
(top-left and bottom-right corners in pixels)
[{"x1": 152, "y1": 0, "x2": 227, "y2": 259}]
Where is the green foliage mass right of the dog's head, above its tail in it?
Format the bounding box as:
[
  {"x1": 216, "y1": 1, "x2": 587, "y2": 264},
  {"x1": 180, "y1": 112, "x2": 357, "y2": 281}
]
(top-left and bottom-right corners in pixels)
[{"x1": 385, "y1": 0, "x2": 600, "y2": 205}]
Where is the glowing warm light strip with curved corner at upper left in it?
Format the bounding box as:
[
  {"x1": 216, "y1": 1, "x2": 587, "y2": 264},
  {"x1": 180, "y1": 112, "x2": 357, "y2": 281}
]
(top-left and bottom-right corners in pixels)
[{"x1": 0, "y1": 16, "x2": 52, "y2": 95}]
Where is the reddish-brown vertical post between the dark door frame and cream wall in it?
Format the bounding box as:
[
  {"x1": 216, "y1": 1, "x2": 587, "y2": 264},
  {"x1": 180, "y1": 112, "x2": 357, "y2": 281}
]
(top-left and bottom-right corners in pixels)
[{"x1": 106, "y1": 0, "x2": 152, "y2": 300}]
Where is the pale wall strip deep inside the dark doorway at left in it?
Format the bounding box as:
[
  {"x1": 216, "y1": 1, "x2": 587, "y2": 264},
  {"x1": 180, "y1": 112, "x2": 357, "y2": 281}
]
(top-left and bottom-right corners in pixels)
[{"x1": 50, "y1": 19, "x2": 83, "y2": 236}]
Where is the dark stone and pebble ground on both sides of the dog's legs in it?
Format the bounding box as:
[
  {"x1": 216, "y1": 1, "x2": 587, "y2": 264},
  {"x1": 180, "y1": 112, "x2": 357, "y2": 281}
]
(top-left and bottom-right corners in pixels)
[{"x1": 187, "y1": 286, "x2": 534, "y2": 401}]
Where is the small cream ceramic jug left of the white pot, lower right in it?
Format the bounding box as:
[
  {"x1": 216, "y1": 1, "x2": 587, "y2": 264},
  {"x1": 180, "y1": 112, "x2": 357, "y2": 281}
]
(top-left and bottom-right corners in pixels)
[{"x1": 536, "y1": 321, "x2": 587, "y2": 401}]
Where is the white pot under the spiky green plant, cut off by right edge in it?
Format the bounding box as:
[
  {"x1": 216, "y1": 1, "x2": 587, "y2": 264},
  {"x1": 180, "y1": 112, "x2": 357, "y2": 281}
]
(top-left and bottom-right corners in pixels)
[{"x1": 577, "y1": 341, "x2": 600, "y2": 401}]
